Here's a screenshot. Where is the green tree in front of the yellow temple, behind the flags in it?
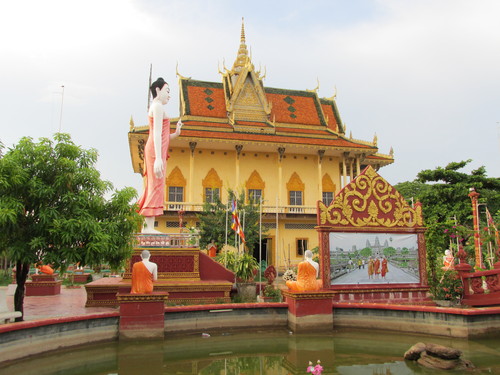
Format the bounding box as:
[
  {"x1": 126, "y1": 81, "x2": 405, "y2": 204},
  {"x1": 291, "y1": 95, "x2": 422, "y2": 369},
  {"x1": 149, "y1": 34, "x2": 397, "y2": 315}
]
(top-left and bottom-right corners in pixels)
[{"x1": 198, "y1": 190, "x2": 266, "y2": 252}]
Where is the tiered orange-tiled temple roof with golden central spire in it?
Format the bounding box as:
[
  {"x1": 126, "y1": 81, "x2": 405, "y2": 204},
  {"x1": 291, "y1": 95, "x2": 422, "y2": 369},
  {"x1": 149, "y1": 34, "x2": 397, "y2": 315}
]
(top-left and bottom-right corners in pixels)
[{"x1": 130, "y1": 19, "x2": 394, "y2": 171}]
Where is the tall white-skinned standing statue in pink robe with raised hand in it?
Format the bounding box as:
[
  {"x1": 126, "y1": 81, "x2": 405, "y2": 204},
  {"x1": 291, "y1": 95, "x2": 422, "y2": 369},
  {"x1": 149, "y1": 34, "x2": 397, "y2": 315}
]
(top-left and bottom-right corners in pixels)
[{"x1": 137, "y1": 78, "x2": 183, "y2": 233}]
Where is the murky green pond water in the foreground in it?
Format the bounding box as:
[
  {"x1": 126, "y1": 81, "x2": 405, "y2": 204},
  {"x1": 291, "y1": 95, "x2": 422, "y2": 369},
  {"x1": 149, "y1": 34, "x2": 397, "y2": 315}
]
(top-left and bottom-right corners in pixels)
[{"x1": 0, "y1": 330, "x2": 500, "y2": 375}]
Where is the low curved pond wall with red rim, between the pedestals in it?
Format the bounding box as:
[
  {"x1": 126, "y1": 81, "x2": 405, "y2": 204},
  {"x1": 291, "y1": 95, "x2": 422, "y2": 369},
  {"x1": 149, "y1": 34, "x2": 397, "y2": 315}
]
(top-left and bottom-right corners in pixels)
[{"x1": 0, "y1": 303, "x2": 500, "y2": 362}]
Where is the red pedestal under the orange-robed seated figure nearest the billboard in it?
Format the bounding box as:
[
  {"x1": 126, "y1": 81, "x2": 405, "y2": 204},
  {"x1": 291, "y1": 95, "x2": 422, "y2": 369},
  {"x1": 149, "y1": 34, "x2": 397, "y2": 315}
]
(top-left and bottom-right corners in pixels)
[{"x1": 281, "y1": 290, "x2": 333, "y2": 332}]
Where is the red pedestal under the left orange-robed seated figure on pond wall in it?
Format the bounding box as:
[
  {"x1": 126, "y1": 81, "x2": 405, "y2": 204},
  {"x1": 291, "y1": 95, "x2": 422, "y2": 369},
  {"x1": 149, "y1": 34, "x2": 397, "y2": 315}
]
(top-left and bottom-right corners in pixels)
[{"x1": 117, "y1": 292, "x2": 168, "y2": 340}]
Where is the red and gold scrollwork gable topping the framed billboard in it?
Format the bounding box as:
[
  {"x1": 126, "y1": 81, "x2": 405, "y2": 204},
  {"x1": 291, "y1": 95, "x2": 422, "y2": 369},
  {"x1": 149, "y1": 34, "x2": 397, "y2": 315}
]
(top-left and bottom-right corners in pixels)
[{"x1": 318, "y1": 166, "x2": 423, "y2": 231}]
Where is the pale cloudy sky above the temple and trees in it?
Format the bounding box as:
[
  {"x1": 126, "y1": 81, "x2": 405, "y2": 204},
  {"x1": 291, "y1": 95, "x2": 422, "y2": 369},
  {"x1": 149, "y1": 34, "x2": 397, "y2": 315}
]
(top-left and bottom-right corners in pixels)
[{"x1": 0, "y1": 0, "x2": 500, "y2": 195}]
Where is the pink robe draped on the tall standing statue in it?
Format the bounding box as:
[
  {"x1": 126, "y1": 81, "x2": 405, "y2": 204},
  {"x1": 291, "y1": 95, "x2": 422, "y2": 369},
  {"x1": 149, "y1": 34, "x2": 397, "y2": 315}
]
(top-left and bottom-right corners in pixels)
[{"x1": 137, "y1": 117, "x2": 170, "y2": 217}]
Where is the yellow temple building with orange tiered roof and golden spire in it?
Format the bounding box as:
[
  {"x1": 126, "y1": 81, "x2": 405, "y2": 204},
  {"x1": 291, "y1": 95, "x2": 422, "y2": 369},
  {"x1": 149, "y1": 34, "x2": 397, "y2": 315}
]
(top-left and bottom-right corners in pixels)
[{"x1": 129, "y1": 25, "x2": 394, "y2": 270}]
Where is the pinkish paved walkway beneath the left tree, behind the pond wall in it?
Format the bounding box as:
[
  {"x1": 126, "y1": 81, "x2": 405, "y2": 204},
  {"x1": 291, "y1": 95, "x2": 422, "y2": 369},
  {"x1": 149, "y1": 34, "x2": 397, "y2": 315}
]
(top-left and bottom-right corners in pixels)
[{"x1": 7, "y1": 284, "x2": 118, "y2": 320}]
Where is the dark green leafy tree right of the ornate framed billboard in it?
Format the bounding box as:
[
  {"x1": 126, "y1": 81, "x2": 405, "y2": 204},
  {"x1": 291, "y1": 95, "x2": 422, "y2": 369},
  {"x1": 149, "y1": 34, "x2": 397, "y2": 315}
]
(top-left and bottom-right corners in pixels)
[{"x1": 395, "y1": 160, "x2": 500, "y2": 282}]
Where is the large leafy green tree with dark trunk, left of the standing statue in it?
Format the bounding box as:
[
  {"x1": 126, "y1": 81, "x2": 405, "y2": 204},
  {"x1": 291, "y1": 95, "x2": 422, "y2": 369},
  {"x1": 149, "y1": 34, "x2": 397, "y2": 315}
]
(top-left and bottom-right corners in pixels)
[{"x1": 0, "y1": 134, "x2": 142, "y2": 320}]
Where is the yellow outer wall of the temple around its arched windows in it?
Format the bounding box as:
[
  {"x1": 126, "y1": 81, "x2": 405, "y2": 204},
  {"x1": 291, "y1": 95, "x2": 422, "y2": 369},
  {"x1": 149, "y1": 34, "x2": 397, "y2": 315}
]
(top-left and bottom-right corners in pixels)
[{"x1": 157, "y1": 144, "x2": 341, "y2": 270}]
